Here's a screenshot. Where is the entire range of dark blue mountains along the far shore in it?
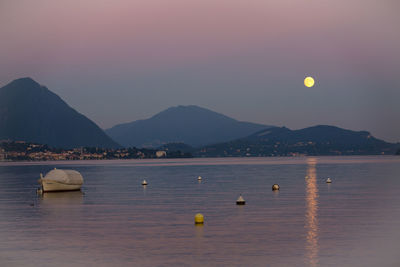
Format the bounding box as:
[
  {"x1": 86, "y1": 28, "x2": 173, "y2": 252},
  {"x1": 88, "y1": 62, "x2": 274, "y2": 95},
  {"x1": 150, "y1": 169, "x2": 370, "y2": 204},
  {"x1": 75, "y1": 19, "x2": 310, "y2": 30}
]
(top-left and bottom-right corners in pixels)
[{"x1": 0, "y1": 77, "x2": 400, "y2": 156}]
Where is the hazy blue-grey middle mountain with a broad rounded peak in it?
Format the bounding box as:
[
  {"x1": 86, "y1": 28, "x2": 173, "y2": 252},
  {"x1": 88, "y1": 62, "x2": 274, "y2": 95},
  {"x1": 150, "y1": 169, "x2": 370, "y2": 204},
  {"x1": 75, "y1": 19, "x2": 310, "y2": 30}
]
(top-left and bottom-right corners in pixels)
[{"x1": 106, "y1": 106, "x2": 268, "y2": 147}]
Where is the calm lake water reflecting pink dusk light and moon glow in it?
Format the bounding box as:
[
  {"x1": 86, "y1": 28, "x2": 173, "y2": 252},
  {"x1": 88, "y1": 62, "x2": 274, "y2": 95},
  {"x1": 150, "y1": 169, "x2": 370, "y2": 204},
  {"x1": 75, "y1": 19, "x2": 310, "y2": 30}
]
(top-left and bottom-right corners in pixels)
[{"x1": 0, "y1": 156, "x2": 400, "y2": 266}]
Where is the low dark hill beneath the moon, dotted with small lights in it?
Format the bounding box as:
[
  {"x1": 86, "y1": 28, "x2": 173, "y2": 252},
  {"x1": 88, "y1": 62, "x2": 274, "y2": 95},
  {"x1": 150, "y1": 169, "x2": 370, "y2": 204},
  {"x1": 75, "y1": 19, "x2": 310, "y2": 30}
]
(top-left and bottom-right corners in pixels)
[{"x1": 195, "y1": 125, "x2": 398, "y2": 157}]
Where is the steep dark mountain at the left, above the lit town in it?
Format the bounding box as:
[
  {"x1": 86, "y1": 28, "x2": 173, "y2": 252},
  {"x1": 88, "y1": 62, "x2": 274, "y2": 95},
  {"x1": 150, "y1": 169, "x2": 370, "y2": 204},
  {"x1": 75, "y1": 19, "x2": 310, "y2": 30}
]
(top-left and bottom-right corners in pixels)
[{"x1": 0, "y1": 78, "x2": 119, "y2": 148}]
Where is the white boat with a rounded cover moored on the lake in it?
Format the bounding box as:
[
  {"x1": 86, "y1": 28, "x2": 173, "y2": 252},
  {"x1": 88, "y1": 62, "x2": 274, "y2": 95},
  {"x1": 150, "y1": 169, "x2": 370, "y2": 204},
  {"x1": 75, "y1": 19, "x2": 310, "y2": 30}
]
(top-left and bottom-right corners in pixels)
[{"x1": 38, "y1": 168, "x2": 83, "y2": 192}]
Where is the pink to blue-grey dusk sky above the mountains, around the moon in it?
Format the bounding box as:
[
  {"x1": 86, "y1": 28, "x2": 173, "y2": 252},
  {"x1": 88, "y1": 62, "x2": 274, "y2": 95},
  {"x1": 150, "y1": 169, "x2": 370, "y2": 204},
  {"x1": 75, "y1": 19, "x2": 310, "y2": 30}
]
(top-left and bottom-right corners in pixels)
[{"x1": 0, "y1": 0, "x2": 400, "y2": 142}]
